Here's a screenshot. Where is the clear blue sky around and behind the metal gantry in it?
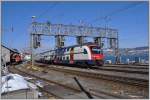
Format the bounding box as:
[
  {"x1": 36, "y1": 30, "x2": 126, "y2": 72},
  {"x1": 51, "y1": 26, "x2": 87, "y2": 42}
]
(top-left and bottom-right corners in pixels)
[{"x1": 2, "y1": 1, "x2": 149, "y2": 49}]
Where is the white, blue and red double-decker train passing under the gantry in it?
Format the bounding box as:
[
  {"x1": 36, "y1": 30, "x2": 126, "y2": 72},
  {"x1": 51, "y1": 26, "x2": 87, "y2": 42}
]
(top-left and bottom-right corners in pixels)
[{"x1": 36, "y1": 43, "x2": 104, "y2": 66}]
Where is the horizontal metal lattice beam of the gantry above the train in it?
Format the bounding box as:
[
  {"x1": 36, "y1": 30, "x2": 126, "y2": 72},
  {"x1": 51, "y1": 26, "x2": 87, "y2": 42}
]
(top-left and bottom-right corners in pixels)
[{"x1": 31, "y1": 22, "x2": 118, "y2": 38}]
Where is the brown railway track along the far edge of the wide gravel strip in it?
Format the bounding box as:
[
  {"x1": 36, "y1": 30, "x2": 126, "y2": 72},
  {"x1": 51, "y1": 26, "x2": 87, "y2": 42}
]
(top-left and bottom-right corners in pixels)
[{"x1": 34, "y1": 64, "x2": 148, "y2": 87}]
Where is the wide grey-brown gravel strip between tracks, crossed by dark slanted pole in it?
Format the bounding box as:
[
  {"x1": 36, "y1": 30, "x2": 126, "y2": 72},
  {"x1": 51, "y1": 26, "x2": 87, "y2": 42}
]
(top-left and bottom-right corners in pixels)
[{"x1": 14, "y1": 66, "x2": 149, "y2": 98}]
